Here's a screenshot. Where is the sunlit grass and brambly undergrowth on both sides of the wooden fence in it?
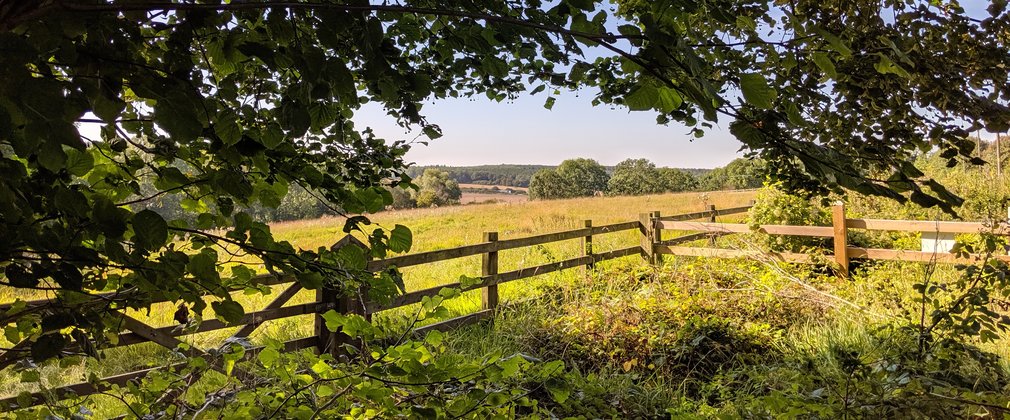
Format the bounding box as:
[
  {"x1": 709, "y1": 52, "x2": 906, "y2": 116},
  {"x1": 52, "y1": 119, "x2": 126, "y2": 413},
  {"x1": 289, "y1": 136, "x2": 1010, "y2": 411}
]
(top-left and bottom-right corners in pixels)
[{"x1": 7, "y1": 182, "x2": 1010, "y2": 418}]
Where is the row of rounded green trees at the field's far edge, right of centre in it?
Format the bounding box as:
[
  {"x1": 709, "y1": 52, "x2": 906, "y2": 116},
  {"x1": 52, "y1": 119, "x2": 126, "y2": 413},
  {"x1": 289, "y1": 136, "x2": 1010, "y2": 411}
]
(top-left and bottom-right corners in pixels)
[{"x1": 529, "y1": 159, "x2": 766, "y2": 200}]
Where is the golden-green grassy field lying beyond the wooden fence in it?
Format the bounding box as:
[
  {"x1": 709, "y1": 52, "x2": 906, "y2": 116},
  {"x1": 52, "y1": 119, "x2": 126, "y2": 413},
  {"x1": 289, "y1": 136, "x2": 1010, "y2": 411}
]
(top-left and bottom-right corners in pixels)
[{"x1": 0, "y1": 192, "x2": 753, "y2": 418}]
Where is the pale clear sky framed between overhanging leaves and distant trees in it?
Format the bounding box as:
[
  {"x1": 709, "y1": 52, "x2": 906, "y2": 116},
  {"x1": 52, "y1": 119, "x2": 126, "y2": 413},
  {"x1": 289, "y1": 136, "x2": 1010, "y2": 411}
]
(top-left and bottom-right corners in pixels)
[{"x1": 356, "y1": 92, "x2": 740, "y2": 168}]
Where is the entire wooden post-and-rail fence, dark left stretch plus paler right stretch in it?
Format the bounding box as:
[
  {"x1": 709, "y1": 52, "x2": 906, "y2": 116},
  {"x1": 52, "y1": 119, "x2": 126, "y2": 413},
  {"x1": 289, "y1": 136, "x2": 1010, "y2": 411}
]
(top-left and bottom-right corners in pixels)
[{"x1": 9, "y1": 201, "x2": 1010, "y2": 411}]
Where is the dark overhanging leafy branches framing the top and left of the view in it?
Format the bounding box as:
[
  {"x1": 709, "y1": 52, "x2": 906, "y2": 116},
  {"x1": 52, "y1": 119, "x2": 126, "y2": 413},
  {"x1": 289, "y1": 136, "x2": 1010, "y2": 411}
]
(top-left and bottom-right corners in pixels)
[{"x1": 0, "y1": 0, "x2": 1010, "y2": 411}]
